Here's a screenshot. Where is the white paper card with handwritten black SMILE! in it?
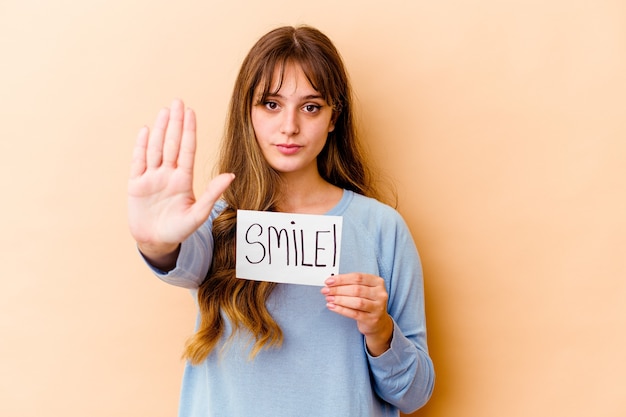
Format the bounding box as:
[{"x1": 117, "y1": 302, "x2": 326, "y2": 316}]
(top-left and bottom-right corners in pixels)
[{"x1": 236, "y1": 210, "x2": 343, "y2": 286}]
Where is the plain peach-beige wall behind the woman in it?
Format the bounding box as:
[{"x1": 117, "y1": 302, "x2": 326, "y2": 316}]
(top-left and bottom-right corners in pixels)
[{"x1": 0, "y1": 0, "x2": 626, "y2": 417}]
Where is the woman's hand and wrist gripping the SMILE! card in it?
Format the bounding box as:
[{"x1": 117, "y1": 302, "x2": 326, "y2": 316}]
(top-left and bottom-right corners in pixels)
[{"x1": 322, "y1": 272, "x2": 393, "y2": 356}]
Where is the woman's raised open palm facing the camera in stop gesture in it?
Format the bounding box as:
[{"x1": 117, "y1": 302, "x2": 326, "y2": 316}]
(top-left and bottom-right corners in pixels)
[{"x1": 128, "y1": 100, "x2": 234, "y2": 266}]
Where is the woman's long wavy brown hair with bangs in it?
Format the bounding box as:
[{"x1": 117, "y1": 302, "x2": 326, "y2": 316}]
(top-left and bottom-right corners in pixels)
[{"x1": 184, "y1": 26, "x2": 378, "y2": 364}]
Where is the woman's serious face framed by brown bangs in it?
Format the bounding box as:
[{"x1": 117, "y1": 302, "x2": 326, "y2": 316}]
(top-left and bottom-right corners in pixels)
[{"x1": 251, "y1": 63, "x2": 335, "y2": 180}]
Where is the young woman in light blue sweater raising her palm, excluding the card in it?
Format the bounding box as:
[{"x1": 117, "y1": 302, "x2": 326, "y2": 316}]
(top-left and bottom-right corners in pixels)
[{"x1": 129, "y1": 27, "x2": 434, "y2": 417}]
